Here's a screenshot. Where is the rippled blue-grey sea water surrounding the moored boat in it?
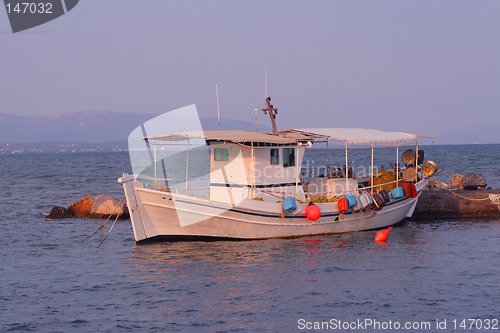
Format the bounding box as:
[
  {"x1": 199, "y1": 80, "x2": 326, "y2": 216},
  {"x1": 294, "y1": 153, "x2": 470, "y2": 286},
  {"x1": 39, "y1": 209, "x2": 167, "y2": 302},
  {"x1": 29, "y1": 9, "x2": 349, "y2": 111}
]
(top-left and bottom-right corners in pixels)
[{"x1": 0, "y1": 145, "x2": 500, "y2": 332}]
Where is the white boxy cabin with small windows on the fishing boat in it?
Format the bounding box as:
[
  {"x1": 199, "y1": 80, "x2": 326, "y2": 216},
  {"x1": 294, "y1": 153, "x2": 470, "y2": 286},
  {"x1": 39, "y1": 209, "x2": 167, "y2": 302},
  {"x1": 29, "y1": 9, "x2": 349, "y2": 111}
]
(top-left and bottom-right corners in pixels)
[{"x1": 205, "y1": 131, "x2": 305, "y2": 205}]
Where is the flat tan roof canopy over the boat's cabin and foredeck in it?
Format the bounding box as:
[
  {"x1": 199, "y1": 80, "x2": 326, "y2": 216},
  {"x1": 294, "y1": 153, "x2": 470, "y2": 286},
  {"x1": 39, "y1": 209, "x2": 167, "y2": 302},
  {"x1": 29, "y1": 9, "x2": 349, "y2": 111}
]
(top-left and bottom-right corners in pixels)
[{"x1": 144, "y1": 130, "x2": 297, "y2": 145}]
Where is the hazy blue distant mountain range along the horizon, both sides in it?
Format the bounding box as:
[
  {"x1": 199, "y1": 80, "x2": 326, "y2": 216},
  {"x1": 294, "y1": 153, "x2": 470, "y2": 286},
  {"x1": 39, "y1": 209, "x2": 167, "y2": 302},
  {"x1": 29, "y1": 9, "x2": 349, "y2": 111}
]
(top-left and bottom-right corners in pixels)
[{"x1": 0, "y1": 111, "x2": 500, "y2": 152}]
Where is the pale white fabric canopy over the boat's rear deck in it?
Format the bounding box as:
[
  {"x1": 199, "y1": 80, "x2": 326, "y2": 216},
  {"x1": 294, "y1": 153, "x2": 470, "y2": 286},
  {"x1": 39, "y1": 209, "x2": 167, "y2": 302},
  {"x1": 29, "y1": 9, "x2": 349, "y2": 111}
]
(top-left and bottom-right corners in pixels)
[{"x1": 280, "y1": 128, "x2": 419, "y2": 146}]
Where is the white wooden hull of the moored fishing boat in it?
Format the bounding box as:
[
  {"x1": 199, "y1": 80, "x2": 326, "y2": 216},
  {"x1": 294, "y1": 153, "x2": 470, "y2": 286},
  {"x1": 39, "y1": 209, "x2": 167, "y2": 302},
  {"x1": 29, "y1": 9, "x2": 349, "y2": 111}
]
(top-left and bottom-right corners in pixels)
[{"x1": 119, "y1": 175, "x2": 425, "y2": 242}]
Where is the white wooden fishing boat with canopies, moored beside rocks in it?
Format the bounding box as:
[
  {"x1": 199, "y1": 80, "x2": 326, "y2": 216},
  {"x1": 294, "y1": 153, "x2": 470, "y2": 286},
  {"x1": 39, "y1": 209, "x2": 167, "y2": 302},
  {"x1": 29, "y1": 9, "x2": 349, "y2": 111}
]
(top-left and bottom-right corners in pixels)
[{"x1": 118, "y1": 98, "x2": 437, "y2": 242}]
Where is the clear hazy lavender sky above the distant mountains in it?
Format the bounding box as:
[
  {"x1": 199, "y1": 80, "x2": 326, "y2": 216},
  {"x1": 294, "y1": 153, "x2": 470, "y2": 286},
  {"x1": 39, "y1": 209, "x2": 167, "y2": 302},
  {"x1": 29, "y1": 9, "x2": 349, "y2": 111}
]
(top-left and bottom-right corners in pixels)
[{"x1": 0, "y1": 0, "x2": 500, "y2": 135}]
